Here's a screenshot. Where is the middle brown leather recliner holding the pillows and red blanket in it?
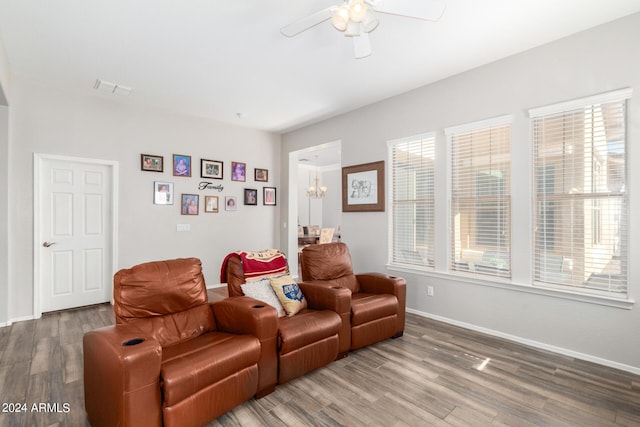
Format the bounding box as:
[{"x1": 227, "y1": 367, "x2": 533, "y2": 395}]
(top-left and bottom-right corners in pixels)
[{"x1": 222, "y1": 252, "x2": 350, "y2": 384}]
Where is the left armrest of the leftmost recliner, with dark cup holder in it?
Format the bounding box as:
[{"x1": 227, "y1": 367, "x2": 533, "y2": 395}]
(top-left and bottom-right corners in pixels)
[{"x1": 83, "y1": 324, "x2": 162, "y2": 427}]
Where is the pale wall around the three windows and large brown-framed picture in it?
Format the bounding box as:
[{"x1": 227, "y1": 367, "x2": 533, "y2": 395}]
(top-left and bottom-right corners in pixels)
[{"x1": 282, "y1": 14, "x2": 640, "y2": 373}]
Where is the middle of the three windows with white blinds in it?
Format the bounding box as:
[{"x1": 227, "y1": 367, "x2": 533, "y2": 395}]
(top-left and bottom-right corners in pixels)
[{"x1": 445, "y1": 117, "x2": 511, "y2": 278}]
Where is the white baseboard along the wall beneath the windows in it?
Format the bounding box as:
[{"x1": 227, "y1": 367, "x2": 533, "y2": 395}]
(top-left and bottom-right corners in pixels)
[{"x1": 407, "y1": 308, "x2": 640, "y2": 375}]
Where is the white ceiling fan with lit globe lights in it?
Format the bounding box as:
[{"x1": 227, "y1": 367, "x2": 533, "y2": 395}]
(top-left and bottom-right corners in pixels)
[{"x1": 280, "y1": 0, "x2": 445, "y2": 58}]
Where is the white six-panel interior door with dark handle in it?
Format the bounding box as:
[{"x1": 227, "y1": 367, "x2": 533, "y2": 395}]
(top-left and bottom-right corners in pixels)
[{"x1": 35, "y1": 158, "x2": 115, "y2": 312}]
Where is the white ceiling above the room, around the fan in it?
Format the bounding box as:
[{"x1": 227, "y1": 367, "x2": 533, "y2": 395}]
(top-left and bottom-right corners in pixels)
[{"x1": 0, "y1": 0, "x2": 640, "y2": 132}]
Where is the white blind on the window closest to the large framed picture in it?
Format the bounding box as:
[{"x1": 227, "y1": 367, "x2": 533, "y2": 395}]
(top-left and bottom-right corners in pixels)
[{"x1": 389, "y1": 134, "x2": 435, "y2": 267}]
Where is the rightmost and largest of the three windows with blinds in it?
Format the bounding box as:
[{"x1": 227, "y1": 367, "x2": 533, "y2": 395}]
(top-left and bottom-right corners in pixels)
[{"x1": 530, "y1": 90, "x2": 631, "y2": 298}]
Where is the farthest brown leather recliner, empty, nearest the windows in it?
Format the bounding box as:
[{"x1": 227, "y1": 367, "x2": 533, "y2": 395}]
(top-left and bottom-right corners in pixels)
[{"x1": 300, "y1": 242, "x2": 407, "y2": 352}]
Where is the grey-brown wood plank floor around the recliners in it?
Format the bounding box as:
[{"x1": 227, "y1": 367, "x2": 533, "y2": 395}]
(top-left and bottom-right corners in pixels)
[{"x1": 0, "y1": 305, "x2": 640, "y2": 427}]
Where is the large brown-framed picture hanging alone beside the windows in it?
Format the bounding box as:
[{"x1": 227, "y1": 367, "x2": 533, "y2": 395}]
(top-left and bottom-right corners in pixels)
[{"x1": 342, "y1": 161, "x2": 385, "y2": 212}]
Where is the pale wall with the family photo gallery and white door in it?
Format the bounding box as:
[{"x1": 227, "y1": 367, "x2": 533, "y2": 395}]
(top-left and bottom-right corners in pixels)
[{"x1": 8, "y1": 76, "x2": 282, "y2": 319}]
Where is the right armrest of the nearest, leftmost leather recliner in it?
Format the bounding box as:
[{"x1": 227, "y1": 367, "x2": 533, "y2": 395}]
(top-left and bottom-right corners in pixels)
[{"x1": 211, "y1": 296, "x2": 278, "y2": 398}]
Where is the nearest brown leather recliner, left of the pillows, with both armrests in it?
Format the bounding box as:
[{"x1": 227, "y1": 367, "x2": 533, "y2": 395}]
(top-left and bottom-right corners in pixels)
[{"x1": 83, "y1": 258, "x2": 277, "y2": 427}]
